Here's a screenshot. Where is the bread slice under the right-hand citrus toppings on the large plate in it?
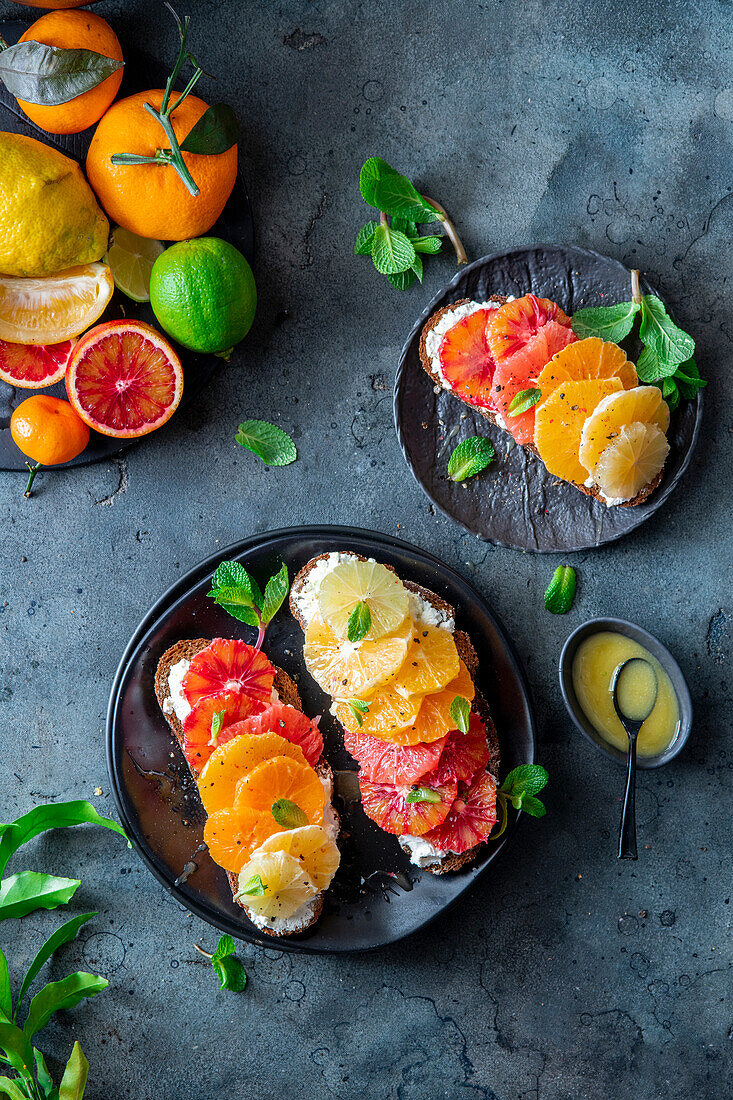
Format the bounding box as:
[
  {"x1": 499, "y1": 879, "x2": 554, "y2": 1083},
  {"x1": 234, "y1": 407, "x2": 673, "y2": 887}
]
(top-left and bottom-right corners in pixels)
[{"x1": 291, "y1": 550, "x2": 501, "y2": 875}]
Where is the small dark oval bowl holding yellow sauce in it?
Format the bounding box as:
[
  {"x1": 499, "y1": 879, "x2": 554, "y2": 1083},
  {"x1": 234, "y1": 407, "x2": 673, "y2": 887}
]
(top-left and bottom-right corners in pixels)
[{"x1": 559, "y1": 618, "x2": 692, "y2": 768}]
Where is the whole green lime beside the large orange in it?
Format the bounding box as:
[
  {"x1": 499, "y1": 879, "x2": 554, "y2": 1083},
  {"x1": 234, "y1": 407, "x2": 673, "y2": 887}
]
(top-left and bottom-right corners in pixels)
[{"x1": 150, "y1": 237, "x2": 258, "y2": 352}]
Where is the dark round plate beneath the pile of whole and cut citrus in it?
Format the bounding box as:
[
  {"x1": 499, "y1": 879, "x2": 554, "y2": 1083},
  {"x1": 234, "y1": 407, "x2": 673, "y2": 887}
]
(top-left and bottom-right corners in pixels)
[{"x1": 0, "y1": 20, "x2": 254, "y2": 470}]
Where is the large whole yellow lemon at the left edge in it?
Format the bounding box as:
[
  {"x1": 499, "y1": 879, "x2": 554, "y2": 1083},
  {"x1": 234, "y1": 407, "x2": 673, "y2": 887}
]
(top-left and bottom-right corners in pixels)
[{"x1": 0, "y1": 133, "x2": 109, "y2": 277}]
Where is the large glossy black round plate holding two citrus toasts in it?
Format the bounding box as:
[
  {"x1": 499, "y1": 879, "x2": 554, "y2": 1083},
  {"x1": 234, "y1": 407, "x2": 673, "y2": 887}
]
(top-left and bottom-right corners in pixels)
[{"x1": 107, "y1": 527, "x2": 535, "y2": 954}]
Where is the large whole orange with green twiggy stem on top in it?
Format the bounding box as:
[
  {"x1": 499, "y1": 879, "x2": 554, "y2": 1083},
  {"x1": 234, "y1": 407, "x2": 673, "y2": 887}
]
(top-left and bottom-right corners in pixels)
[{"x1": 87, "y1": 89, "x2": 237, "y2": 241}]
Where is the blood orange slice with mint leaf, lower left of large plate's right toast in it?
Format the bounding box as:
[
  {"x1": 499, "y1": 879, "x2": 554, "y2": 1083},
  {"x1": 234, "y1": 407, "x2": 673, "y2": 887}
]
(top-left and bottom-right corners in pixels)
[{"x1": 359, "y1": 772, "x2": 458, "y2": 836}]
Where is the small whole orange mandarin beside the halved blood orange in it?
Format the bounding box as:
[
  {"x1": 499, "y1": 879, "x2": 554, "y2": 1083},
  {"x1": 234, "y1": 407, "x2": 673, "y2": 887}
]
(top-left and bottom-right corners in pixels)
[{"x1": 10, "y1": 394, "x2": 89, "y2": 466}]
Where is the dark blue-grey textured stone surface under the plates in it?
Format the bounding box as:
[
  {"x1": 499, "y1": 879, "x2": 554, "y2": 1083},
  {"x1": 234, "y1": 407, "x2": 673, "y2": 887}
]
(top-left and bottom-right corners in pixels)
[{"x1": 0, "y1": 0, "x2": 733, "y2": 1100}]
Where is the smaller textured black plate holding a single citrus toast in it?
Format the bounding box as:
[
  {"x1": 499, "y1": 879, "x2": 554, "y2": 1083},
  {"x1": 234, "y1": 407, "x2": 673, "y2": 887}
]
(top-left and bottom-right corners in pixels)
[{"x1": 394, "y1": 245, "x2": 702, "y2": 553}]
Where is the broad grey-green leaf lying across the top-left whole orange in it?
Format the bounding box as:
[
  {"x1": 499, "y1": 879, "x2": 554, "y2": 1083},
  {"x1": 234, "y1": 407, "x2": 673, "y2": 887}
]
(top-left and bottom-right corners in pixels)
[{"x1": 0, "y1": 41, "x2": 124, "y2": 107}]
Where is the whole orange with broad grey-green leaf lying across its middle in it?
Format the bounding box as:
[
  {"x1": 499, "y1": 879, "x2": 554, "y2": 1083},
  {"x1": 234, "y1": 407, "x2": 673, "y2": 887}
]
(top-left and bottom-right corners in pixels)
[{"x1": 18, "y1": 11, "x2": 122, "y2": 134}]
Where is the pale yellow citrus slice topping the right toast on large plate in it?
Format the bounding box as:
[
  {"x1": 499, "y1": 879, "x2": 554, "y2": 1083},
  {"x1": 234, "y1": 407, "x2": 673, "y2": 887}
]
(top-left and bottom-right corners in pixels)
[{"x1": 318, "y1": 561, "x2": 409, "y2": 641}]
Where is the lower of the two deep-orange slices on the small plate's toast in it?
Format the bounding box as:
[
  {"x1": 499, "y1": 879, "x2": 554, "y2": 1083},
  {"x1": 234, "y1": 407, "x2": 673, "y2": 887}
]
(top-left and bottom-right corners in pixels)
[{"x1": 535, "y1": 378, "x2": 621, "y2": 485}]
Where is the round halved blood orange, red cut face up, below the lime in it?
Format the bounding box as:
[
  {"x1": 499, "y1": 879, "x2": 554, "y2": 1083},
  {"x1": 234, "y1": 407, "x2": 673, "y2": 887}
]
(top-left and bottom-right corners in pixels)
[{"x1": 66, "y1": 321, "x2": 184, "y2": 439}]
